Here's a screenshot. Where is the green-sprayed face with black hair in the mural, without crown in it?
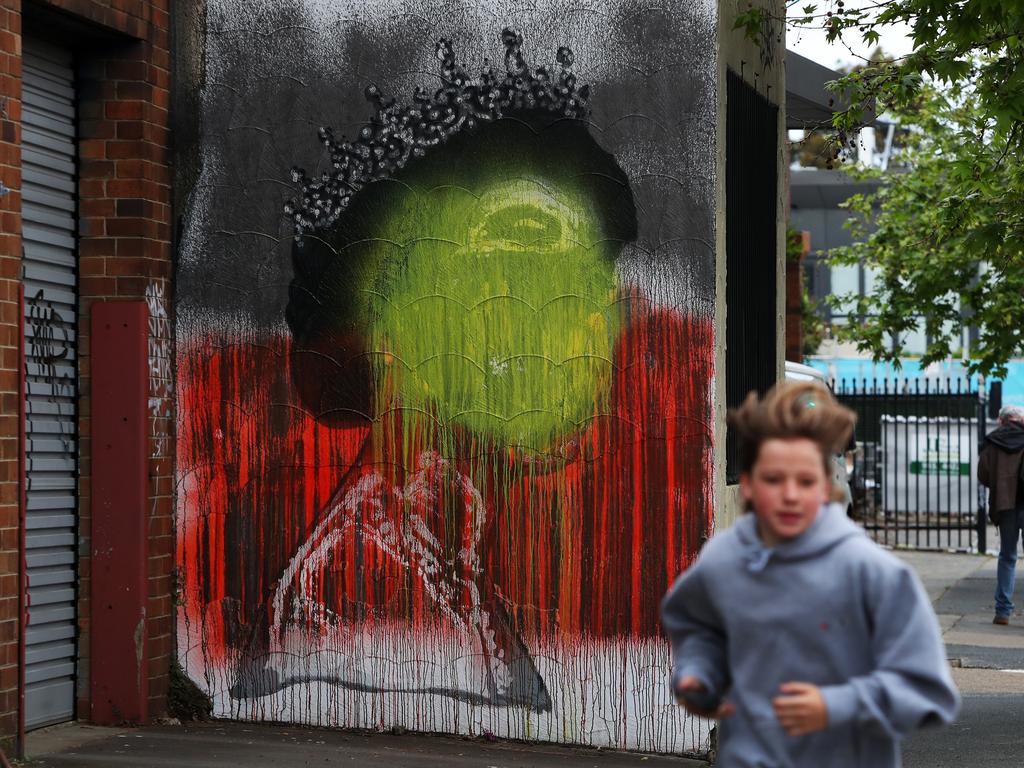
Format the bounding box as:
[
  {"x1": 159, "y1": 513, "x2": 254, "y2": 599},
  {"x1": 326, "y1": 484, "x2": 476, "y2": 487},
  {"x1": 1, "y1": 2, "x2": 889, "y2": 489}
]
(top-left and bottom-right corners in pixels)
[{"x1": 289, "y1": 115, "x2": 636, "y2": 457}]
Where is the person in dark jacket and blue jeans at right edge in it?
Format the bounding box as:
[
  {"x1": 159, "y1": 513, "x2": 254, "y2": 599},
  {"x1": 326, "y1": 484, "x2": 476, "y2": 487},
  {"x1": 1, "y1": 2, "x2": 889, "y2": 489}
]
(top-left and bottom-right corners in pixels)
[{"x1": 978, "y1": 406, "x2": 1024, "y2": 625}]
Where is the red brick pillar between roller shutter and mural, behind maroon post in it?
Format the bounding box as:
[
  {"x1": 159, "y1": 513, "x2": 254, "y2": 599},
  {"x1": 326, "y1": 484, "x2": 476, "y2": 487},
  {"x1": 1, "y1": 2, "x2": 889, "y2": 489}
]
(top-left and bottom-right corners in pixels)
[{"x1": 74, "y1": 0, "x2": 174, "y2": 715}]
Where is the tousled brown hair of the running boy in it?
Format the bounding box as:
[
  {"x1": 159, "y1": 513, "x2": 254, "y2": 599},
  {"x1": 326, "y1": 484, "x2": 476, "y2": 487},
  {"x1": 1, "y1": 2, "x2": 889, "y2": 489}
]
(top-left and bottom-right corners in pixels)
[{"x1": 728, "y1": 381, "x2": 857, "y2": 479}]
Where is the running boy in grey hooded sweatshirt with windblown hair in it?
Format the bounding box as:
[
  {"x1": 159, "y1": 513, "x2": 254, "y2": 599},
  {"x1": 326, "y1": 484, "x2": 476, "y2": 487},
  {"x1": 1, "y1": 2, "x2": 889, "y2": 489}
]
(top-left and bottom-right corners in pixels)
[{"x1": 662, "y1": 383, "x2": 959, "y2": 768}]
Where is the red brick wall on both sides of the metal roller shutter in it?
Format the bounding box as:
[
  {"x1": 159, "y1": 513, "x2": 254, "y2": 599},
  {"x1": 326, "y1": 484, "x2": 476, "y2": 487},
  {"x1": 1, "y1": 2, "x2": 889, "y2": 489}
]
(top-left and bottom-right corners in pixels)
[{"x1": 0, "y1": 0, "x2": 174, "y2": 735}]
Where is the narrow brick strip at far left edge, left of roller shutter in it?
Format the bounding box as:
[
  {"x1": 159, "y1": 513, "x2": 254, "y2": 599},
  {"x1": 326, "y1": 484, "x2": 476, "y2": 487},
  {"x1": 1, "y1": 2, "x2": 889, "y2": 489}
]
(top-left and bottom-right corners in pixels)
[{"x1": 0, "y1": 0, "x2": 22, "y2": 750}]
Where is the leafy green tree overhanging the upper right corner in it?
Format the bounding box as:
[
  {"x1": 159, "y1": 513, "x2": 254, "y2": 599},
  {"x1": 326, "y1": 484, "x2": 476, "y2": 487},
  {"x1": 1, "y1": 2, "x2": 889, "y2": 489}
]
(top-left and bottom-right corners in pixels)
[{"x1": 736, "y1": 0, "x2": 1024, "y2": 374}]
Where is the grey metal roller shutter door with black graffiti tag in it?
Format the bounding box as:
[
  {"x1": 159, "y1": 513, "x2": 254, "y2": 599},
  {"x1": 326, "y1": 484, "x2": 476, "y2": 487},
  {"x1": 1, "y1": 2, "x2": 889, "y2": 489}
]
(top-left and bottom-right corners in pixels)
[{"x1": 22, "y1": 39, "x2": 78, "y2": 728}]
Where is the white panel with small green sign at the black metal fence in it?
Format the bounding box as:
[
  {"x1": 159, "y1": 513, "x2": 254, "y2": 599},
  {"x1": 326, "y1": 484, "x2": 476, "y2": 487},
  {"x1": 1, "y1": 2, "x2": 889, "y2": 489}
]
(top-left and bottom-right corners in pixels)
[{"x1": 882, "y1": 415, "x2": 978, "y2": 515}]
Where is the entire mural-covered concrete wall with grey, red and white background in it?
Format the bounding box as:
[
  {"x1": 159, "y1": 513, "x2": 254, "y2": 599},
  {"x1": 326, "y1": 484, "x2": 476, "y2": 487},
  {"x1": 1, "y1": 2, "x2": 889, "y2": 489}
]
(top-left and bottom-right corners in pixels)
[{"x1": 175, "y1": 0, "x2": 724, "y2": 751}]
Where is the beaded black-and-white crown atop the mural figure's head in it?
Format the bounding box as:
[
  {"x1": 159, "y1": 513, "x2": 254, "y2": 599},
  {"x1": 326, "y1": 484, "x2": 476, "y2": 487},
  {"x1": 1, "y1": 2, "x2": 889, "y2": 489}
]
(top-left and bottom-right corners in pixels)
[{"x1": 285, "y1": 29, "x2": 590, "y2": 237}]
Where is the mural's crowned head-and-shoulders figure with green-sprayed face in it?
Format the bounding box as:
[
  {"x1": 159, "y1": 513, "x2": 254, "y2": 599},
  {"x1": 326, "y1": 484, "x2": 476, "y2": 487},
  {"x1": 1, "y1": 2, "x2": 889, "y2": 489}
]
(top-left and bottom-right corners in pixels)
[{"x1": 237, "y1": 30, "x2": 636, "y2": 712}]
